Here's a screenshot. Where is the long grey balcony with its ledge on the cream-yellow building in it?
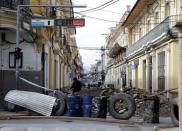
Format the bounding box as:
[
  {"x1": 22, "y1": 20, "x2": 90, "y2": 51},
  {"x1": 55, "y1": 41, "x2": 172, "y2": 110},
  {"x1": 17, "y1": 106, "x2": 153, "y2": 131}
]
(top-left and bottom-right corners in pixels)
[{"x1": 126, "y1": 15, "x2": 179, "y2": 57}]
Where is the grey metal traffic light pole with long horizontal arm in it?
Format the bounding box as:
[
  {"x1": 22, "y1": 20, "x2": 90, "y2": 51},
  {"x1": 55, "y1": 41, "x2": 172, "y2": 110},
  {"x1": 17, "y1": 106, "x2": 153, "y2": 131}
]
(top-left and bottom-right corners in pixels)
[{"x1": 16, "y1": 5, "x2": 86, "y2": 89}]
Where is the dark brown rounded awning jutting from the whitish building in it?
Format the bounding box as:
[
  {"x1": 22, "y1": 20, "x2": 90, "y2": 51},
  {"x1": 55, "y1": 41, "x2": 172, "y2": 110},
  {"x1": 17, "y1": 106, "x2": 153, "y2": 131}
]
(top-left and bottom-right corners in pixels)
[{"x1": 108, "y1": 43, "x2": 126, "y2": 58}]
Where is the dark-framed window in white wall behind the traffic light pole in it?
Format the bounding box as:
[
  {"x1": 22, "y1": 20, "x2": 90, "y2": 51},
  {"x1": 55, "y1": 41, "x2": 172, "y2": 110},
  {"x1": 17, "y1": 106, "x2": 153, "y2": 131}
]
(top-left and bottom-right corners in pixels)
[{"x1": 9, "y1": 52, "x2": 23, "y2": 68}]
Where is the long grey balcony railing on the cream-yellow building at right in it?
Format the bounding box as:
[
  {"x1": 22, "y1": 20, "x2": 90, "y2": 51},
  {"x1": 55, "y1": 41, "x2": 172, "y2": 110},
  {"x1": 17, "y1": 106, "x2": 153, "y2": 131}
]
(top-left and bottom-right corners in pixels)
[{"x1": 126, "y1": 15, "x2": 182, "y2": 56}]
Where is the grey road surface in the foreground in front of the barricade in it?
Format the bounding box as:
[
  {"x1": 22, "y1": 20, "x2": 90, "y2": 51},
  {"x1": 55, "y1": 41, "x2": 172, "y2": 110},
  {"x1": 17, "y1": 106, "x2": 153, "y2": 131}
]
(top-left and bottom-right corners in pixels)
[{"x1": 0, "y1": 117, "x2": 175, "y2": 131}]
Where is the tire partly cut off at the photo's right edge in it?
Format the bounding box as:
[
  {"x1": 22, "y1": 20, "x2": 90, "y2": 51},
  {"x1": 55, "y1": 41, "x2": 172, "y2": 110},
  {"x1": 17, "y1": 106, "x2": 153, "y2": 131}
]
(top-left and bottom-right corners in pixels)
[{"x1": 170, "y1": 98, "x2": 179, "y2": 126}]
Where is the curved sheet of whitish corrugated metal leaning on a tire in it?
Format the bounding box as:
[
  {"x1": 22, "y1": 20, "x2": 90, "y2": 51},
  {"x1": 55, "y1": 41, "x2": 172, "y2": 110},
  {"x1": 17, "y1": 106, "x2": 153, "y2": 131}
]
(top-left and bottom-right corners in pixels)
[{"x1": 4, "y1": 90, "x2": 56, "y2": 116}]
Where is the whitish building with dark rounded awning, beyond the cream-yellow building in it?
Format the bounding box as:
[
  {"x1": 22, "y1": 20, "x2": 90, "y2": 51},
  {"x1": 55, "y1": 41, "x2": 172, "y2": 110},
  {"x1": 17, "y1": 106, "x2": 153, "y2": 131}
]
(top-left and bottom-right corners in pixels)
[{"x1": 105, "y1": 6, "x2": 130, "y2": 89}]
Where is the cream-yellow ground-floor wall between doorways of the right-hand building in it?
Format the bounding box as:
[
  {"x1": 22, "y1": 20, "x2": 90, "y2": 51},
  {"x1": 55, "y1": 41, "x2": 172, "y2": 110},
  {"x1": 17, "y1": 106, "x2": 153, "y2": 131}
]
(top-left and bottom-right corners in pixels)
[{"x1": 127, "y1": 41, "x2": 179, "y2": 91}]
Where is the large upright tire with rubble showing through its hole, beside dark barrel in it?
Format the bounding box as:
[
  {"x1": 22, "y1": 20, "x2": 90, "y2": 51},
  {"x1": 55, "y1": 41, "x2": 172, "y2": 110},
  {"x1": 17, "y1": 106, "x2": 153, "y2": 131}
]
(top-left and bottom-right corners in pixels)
[{"x1": 109, "y1": 93, "x2": 136, "y2": 120}]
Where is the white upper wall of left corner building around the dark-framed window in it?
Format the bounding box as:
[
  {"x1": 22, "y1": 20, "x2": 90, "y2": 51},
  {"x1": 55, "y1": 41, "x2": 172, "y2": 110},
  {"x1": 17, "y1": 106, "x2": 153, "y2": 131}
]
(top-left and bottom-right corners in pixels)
[{"x1": 0, "y1": 31, "x2": 41, "y2": 71}]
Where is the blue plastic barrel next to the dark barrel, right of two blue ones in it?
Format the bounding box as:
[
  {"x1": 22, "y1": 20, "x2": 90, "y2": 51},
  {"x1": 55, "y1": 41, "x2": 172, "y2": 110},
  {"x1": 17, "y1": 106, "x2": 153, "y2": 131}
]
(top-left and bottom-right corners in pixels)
[{"x1": 82, "y1": 96, "x2": 93, "y2": 117}]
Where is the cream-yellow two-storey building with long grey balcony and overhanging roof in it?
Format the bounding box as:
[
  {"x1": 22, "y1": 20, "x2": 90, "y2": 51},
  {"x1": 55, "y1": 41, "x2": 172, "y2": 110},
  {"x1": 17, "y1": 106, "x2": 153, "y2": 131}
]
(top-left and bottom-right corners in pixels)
[{"x1": 122, "y1": 0, "x2": 182, "y2": 93}]
